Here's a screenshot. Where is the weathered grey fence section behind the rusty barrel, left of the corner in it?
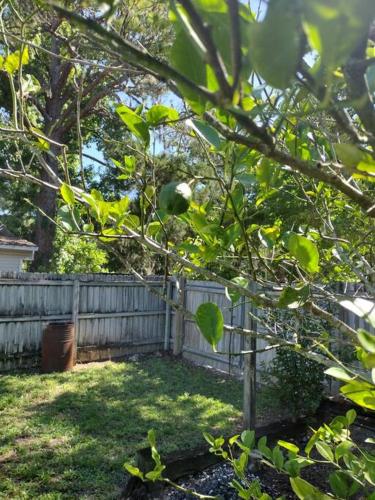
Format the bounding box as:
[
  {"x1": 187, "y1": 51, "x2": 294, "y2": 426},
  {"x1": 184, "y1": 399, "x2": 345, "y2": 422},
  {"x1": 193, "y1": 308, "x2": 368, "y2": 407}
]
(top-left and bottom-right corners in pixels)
[{"x1": 0, "y1": 273, "x2": 165, "y2": 369}]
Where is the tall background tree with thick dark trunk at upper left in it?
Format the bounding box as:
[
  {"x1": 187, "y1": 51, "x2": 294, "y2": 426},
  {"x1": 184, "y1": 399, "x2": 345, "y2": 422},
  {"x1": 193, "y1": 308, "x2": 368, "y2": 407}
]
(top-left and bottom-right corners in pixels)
[{"x1": 0, "y1": 0, "x2": 171, "y2": 270}]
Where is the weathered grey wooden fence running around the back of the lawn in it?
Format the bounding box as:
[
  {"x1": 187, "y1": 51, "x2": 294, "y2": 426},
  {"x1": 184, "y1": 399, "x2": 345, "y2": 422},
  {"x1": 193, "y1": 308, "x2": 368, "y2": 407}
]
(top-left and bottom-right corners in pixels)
[{"x1": 0, "y1": 273, "x2": 374, "y2": 375}]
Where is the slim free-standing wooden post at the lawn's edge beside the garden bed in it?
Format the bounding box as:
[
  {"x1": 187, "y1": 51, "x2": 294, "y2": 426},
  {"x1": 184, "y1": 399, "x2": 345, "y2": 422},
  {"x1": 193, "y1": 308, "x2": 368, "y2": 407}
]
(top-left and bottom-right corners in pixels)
[{"x1": 243, "y1": 284, "x2": 257, "y2": 429}]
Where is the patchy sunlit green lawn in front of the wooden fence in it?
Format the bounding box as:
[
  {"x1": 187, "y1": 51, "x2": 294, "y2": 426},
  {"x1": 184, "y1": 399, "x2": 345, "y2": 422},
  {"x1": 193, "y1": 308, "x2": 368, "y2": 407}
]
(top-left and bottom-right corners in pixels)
[{"x1": 0, "y1": 358, "x2": 242, "y2": 499}]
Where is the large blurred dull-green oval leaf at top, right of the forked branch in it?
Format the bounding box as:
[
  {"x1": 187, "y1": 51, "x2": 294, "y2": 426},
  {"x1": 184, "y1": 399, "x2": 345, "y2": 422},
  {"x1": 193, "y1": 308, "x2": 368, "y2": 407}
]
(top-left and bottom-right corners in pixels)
[{"x1": 250, "y1": 0, "x2": 300, "y2": 89}]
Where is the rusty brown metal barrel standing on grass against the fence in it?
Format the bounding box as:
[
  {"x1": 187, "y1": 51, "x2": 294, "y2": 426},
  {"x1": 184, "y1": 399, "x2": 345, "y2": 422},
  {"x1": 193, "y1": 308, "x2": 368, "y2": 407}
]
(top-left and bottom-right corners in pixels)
[{"x1": 42, "y1": 322, "x2": 75, "y2": 373}]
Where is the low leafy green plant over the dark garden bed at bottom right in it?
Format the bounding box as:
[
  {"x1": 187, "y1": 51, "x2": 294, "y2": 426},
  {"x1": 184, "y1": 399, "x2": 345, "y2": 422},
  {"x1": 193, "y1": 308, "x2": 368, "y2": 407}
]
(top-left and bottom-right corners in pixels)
[{"x1": 125, "y1": 409, "x2": 375, "y2": 500}]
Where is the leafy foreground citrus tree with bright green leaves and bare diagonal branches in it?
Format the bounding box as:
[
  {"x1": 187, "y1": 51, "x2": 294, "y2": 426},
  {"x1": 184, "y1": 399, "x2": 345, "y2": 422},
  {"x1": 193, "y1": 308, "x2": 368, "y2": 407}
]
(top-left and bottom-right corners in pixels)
[{"x1": 1, "y1": 0, "x2": 375, "y2": 498}]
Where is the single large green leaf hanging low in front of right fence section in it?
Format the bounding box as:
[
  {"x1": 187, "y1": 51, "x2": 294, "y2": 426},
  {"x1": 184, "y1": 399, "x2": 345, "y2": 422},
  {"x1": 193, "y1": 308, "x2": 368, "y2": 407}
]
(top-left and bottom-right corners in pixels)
[{"x1": 195, "y1": 302, "x2": 224, "y2": 350}]
